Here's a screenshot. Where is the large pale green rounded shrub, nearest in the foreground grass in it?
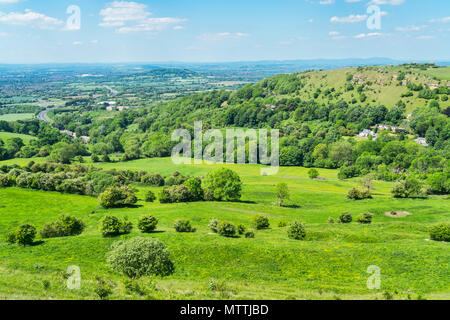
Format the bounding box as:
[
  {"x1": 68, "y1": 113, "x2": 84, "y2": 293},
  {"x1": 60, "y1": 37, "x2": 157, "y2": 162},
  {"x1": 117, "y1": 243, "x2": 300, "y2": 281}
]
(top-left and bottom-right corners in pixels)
[{"x1": 107, "y1": 237, "x2": 175, "y2": 278}]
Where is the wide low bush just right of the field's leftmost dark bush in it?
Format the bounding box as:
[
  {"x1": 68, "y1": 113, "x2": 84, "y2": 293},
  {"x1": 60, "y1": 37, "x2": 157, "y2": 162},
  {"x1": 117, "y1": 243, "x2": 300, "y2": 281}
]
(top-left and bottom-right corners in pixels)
[{"x1": 39, "y1": 215, "x2": 86, "y2": 239}]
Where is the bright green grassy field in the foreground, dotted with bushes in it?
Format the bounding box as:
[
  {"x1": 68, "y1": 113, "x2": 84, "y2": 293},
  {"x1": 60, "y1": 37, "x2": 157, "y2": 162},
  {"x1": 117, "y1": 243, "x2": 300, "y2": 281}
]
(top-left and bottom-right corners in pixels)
[{"x1": 0, "y1": 159, "x2": 450, "y2": 299}]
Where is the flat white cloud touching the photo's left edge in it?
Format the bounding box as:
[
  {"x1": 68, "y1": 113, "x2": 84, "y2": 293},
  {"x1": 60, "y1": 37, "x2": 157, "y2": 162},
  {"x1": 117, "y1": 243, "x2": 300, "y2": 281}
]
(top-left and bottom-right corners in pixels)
[{"x1": 0, "y1": 9, "x2": 64, "y2": 29}]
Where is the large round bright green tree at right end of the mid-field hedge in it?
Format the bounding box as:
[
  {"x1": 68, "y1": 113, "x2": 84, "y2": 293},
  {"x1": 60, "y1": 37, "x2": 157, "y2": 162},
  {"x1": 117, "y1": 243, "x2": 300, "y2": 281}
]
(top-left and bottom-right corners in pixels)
[{"x1": 202, "y1": 168, "x2": 242, "y2": 201}]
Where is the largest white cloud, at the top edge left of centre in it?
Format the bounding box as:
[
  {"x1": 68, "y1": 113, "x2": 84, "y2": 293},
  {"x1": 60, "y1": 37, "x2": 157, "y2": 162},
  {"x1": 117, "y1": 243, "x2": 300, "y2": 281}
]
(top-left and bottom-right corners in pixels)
[{"x1": 99, "y1": 1, "x2": 187, "y2": 34}]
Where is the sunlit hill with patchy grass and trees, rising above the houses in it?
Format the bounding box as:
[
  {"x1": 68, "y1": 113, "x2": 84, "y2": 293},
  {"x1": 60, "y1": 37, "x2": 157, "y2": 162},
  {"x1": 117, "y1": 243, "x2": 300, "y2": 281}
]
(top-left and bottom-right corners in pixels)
[{"x1": 140, "y1": 64, "x2": 450, "y2": 131}]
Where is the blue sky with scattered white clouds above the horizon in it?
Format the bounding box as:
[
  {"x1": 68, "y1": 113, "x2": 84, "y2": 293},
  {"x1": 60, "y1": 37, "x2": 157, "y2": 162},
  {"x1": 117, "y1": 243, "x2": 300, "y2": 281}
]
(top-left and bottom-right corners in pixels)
[{"x1": 0, "y1": 0, "x2": 450, "y2": 64}]
